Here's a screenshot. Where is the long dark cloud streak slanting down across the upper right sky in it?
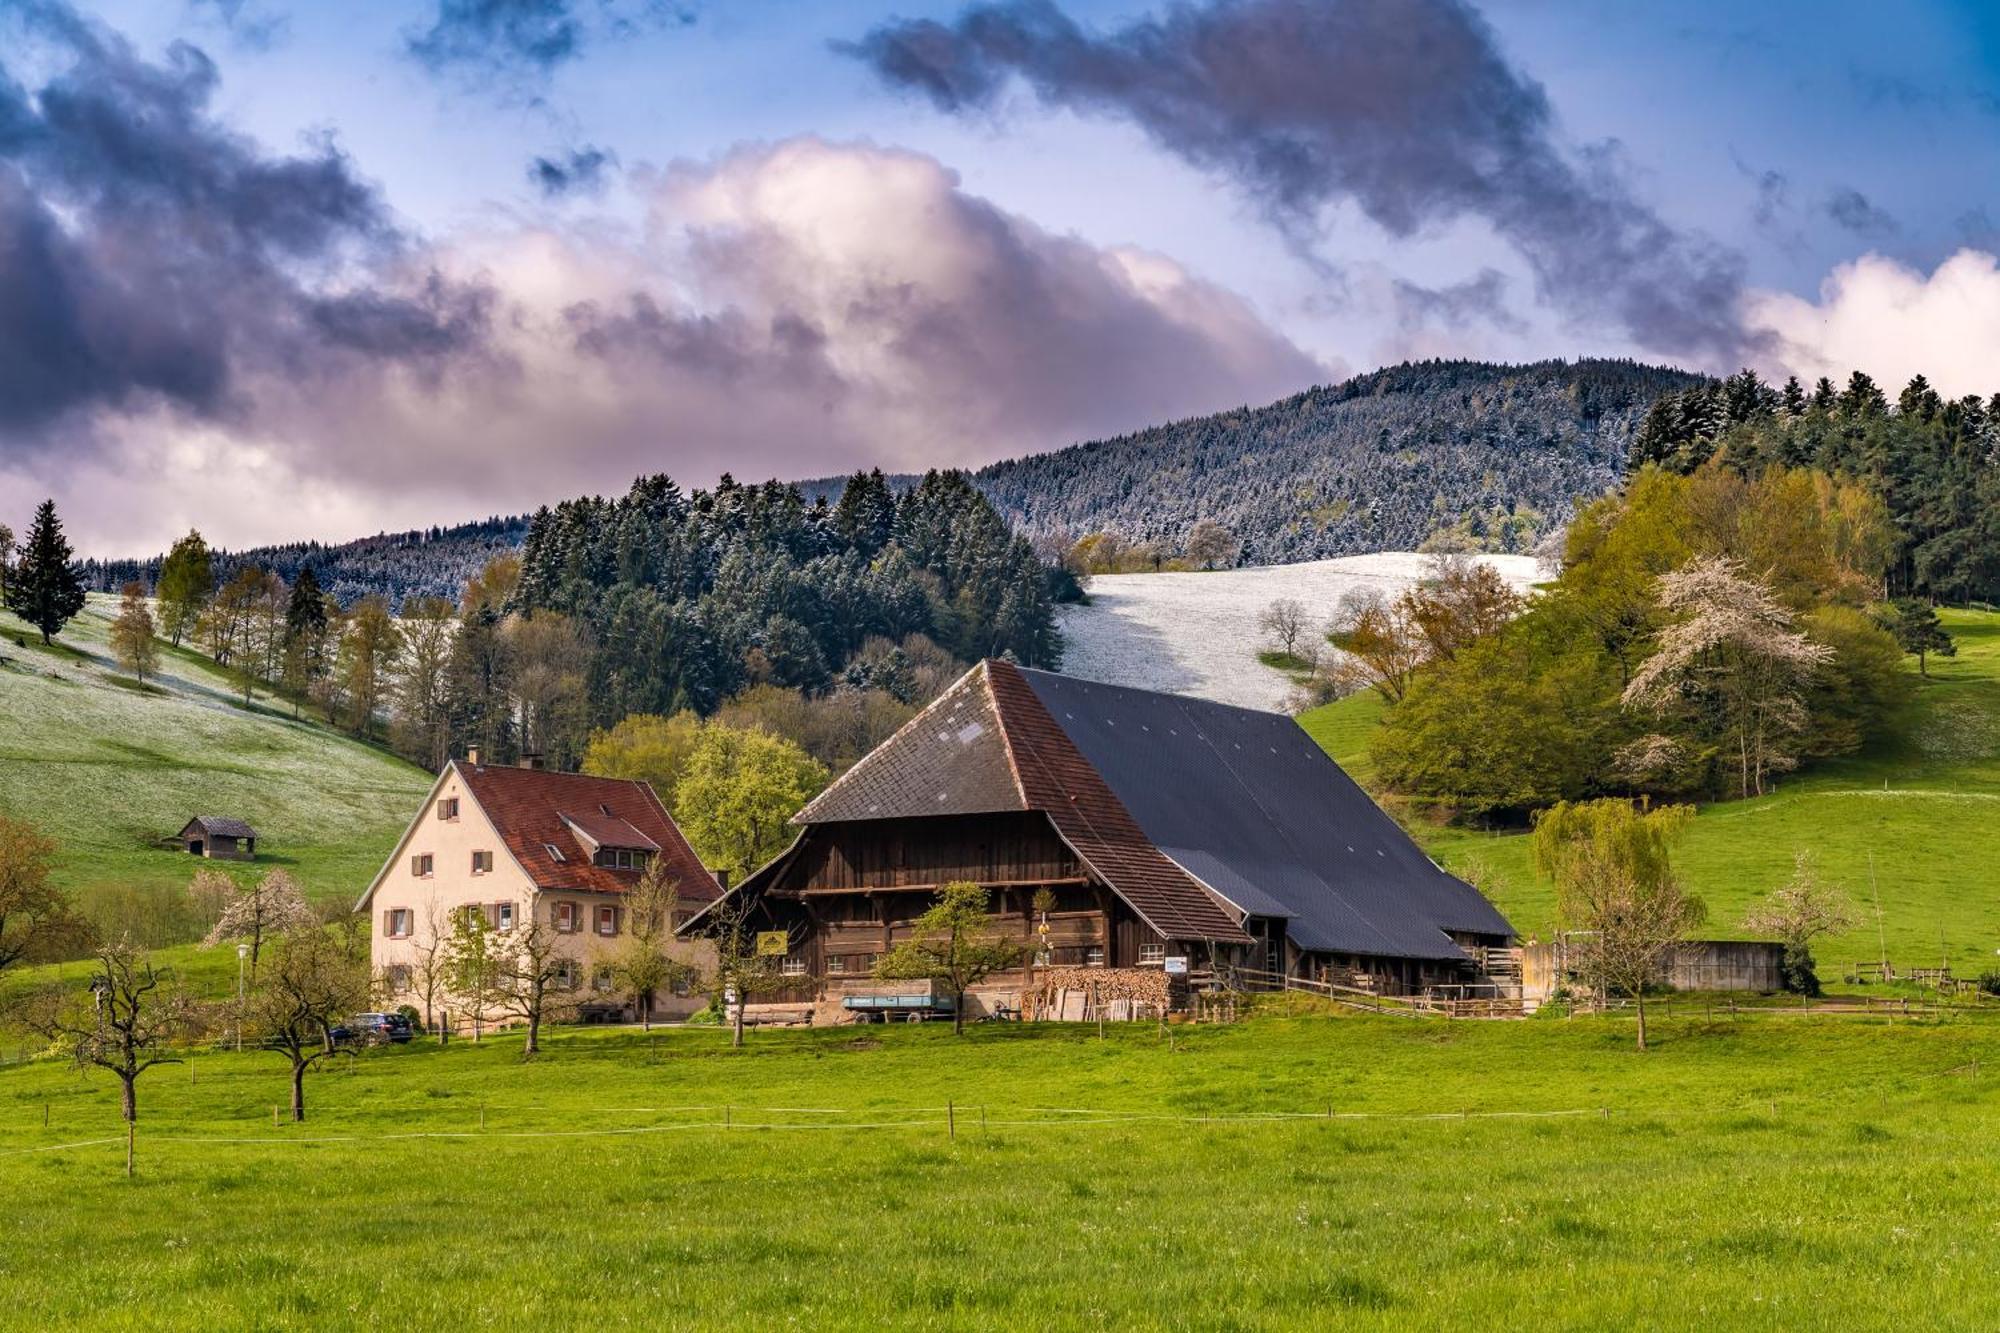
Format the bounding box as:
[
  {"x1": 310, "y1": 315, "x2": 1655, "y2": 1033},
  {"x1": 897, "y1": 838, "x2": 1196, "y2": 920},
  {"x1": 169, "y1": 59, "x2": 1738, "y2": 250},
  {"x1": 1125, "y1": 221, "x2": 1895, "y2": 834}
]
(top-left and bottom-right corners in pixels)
[{"x1": 844, "y1": 0, "x2": 1744, "y2": 364}]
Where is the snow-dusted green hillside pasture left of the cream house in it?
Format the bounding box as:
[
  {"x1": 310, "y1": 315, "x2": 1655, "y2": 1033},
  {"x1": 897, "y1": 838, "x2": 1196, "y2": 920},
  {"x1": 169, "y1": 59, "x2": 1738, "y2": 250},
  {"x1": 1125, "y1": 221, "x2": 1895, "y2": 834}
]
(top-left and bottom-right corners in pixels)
[{"x1": 0, "y1": 596, "x2": 430, "y2": 920}]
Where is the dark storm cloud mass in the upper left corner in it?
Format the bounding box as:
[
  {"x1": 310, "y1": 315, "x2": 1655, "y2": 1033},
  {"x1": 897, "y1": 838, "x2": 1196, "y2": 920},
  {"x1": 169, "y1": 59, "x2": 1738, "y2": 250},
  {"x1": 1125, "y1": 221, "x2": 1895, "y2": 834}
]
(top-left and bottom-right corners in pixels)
[{"x1": 0, "y1": 2, "x2": 480, "y2": 450}]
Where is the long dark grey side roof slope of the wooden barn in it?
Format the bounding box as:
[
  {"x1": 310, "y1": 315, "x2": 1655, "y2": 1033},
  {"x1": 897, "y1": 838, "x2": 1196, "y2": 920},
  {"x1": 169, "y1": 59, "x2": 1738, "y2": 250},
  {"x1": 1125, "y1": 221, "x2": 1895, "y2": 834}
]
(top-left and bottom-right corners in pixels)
[{"x1": 1004, "y1": 667, "x2": 1512, "y2": 959}]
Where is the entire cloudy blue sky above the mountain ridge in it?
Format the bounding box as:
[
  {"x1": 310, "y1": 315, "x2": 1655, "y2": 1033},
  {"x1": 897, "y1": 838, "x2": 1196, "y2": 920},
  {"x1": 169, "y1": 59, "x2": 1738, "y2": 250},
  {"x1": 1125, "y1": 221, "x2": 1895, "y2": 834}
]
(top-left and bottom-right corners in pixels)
[{"x1": 0, "y1": 0, "x2": 2000, "y2": 554}]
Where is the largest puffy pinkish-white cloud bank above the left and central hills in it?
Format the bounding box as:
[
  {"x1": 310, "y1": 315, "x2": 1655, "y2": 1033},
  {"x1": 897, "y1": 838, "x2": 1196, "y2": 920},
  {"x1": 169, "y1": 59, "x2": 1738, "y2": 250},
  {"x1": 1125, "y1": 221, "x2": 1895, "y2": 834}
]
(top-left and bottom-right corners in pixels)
[{"x1": 0, "y1": 101, "x2": 1332, "y2": 552}]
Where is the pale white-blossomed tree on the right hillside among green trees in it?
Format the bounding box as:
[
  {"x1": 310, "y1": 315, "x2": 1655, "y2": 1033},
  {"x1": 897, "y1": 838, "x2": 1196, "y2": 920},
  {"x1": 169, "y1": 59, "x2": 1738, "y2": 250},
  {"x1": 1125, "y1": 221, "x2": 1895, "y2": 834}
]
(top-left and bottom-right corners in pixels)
[{"x1": 1624, "y1": 558, "x2": 1832, "y2": 797}]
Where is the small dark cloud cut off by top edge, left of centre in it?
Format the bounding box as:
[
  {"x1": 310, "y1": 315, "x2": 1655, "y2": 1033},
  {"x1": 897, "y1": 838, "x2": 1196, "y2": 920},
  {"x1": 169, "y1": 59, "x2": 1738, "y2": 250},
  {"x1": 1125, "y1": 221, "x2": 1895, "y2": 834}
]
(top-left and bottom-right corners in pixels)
[{"x1": 404, "y1": 0, "x2": 696, "y2": 80}]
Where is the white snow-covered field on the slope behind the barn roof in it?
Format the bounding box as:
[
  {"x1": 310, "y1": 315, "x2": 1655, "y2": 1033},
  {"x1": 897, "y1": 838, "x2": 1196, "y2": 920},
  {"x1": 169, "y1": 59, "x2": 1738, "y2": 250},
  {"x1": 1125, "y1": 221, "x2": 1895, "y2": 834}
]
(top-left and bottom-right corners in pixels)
[{"x1": 1062, "y1": 550, "x2": 1536, "y2": 709}]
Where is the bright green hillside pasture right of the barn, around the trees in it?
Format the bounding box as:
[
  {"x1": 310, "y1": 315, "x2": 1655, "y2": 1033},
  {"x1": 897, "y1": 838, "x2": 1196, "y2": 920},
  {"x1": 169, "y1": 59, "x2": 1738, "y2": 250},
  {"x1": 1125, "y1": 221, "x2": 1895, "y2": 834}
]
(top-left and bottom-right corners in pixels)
[{"x1": 1300, "y1": 610, "x2": 2000, "y2": 981}]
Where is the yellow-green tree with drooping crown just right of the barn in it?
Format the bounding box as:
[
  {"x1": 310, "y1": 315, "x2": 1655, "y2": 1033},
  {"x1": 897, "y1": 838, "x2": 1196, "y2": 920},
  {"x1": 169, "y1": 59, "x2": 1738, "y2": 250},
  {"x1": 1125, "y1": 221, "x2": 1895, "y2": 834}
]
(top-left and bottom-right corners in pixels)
[{"x1": 1534, "y1": 801, "x2": 1708, "y2": 1051}]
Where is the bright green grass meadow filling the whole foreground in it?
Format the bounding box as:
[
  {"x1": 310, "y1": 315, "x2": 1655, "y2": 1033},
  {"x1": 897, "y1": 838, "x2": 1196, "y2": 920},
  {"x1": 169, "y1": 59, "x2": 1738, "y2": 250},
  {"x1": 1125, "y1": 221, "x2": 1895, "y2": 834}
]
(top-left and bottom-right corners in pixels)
[{"x1": 0, "y1": 1015, "x2": 2000, "y2": 1329}]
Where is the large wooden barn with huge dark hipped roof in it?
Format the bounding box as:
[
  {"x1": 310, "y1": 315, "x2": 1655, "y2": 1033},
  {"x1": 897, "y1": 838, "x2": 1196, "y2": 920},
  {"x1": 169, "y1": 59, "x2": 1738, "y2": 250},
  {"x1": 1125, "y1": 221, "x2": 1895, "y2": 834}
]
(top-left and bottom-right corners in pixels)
[{"x1": 686, "y1": 660, "x2": 1512, "y2": 1005}]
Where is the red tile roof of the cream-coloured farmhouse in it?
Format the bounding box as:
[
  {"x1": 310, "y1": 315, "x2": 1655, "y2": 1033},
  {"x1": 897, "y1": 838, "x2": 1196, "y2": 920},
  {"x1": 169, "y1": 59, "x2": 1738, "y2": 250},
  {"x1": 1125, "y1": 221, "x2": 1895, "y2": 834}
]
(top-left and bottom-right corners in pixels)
[{"x1": 454, "y1": 763, "x2": 720, "y2": 907}]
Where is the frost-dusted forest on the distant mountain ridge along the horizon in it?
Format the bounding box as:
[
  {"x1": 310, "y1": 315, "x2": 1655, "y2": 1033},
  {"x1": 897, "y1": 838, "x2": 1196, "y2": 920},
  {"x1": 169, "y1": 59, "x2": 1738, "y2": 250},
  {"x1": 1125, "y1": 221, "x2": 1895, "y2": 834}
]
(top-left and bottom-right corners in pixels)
[{"x1": 84, "y1": 360, "x2": 1710, "y2": 604}]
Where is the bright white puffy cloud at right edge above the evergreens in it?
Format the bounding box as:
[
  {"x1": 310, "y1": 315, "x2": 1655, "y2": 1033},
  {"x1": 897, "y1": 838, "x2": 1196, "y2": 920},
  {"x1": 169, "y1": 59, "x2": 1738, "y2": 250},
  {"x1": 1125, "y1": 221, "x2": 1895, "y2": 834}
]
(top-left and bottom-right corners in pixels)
[{"x1": 1746, "y1": 250, "x2": 2000, "y2": 396}]
